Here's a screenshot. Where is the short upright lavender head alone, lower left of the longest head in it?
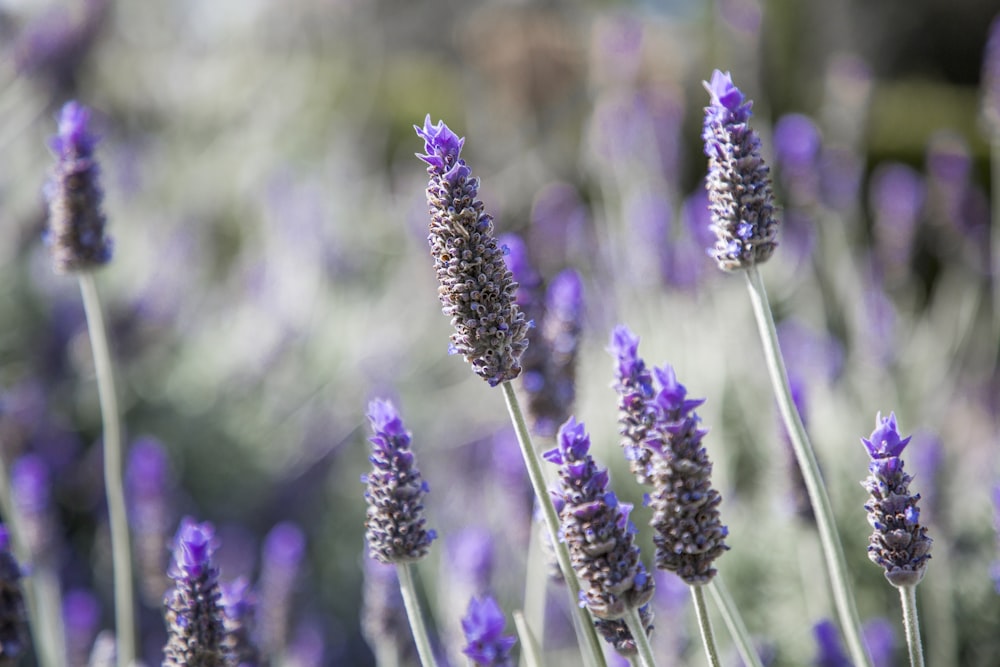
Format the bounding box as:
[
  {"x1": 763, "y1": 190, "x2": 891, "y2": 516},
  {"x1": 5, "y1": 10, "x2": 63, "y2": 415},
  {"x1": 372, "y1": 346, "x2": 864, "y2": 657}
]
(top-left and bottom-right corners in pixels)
[{"x1": 361, "y1": 400, "x2": 437, "y2": 563}]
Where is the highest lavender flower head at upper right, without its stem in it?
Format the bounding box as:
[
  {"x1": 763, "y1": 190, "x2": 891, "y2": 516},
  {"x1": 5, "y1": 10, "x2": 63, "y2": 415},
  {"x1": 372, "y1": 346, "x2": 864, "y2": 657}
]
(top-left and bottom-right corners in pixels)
[{"x1": 701, "y1": 70, "x2": 778, "y2": 271}]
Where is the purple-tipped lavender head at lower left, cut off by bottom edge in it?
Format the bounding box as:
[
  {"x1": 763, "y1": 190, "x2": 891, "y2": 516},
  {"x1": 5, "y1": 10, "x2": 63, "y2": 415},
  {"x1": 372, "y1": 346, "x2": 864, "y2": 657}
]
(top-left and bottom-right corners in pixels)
[{"x1": 163, "y1": 517, "x2": 230, "y2": 667}]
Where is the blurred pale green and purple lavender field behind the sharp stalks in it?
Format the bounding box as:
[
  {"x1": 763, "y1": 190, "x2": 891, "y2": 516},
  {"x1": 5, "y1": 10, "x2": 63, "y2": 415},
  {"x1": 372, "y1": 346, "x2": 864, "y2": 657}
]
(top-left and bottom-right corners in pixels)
[{"x1": 0, "y1": 0, "x2": 1000, "y2": 666}]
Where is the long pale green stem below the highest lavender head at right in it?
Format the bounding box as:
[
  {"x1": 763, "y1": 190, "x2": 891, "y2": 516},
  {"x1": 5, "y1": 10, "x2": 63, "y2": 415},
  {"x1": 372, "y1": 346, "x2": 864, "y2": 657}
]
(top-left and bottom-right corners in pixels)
[{"x1": 746, "y1": 266, "x2": 872, "y2": 667}]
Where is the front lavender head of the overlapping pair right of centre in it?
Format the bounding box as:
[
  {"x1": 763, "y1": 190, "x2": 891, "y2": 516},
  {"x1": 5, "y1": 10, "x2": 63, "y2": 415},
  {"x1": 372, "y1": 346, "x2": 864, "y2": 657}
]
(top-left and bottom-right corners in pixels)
[{"x1": 649, "y1": 366, "x2": 729, "y2": 586}]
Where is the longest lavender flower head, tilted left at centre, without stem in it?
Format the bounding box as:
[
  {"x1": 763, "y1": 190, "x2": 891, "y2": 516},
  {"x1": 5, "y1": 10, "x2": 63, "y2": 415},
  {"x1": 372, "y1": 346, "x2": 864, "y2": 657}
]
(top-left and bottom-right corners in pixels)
[{"x1": 413, "y1": 114, "x2": 528, "y2": 387}]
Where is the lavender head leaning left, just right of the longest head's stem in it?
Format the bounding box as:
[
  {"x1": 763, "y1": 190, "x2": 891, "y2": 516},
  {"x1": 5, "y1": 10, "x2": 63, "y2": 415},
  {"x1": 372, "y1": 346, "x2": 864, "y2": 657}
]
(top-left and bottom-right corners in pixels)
[{"x1": 543, "y1": 417, "x2": 654, "y2": 620}]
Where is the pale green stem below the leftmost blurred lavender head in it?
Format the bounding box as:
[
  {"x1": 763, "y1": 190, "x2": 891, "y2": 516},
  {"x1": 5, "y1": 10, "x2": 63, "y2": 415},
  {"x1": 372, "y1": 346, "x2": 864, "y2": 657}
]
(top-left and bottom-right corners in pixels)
[{"x1": 78, "y1": 271, "x2": 135, "y2": 667}]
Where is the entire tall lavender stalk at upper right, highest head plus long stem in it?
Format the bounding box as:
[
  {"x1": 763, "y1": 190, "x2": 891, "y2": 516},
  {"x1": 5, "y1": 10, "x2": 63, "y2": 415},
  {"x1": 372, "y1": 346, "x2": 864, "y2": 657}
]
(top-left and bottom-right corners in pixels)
[{"x1": 702, "y1": 70, "x2": 871, "y2": 667}]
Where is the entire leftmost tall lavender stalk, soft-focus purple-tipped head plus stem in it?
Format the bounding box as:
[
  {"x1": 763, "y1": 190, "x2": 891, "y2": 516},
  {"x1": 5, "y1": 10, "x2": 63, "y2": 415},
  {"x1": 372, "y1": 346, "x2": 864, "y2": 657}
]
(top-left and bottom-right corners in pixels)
[{"x1": 45, "y1": 102, "x2": 135, "y2": 667}]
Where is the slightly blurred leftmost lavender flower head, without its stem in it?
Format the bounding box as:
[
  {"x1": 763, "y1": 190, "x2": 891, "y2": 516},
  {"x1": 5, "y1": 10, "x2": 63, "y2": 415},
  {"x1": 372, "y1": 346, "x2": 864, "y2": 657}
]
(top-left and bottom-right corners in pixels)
[{"x1": 45, "y1": 102, "x2": 111, "y2": 273}]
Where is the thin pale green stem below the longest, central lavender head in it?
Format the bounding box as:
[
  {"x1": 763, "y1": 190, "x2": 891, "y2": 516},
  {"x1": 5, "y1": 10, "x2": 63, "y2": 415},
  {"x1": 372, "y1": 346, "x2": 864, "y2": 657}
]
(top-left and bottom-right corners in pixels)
[{"x1": 501, "y1": 381, "x2": 607, "y2": 667}]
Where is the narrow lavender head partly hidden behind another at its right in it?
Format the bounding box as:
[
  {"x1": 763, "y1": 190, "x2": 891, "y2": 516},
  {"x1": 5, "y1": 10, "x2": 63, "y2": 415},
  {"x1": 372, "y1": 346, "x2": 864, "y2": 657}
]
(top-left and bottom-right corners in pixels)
[{"x1": 608, "y1": 324, "x2": 656, "y2": 484}]
